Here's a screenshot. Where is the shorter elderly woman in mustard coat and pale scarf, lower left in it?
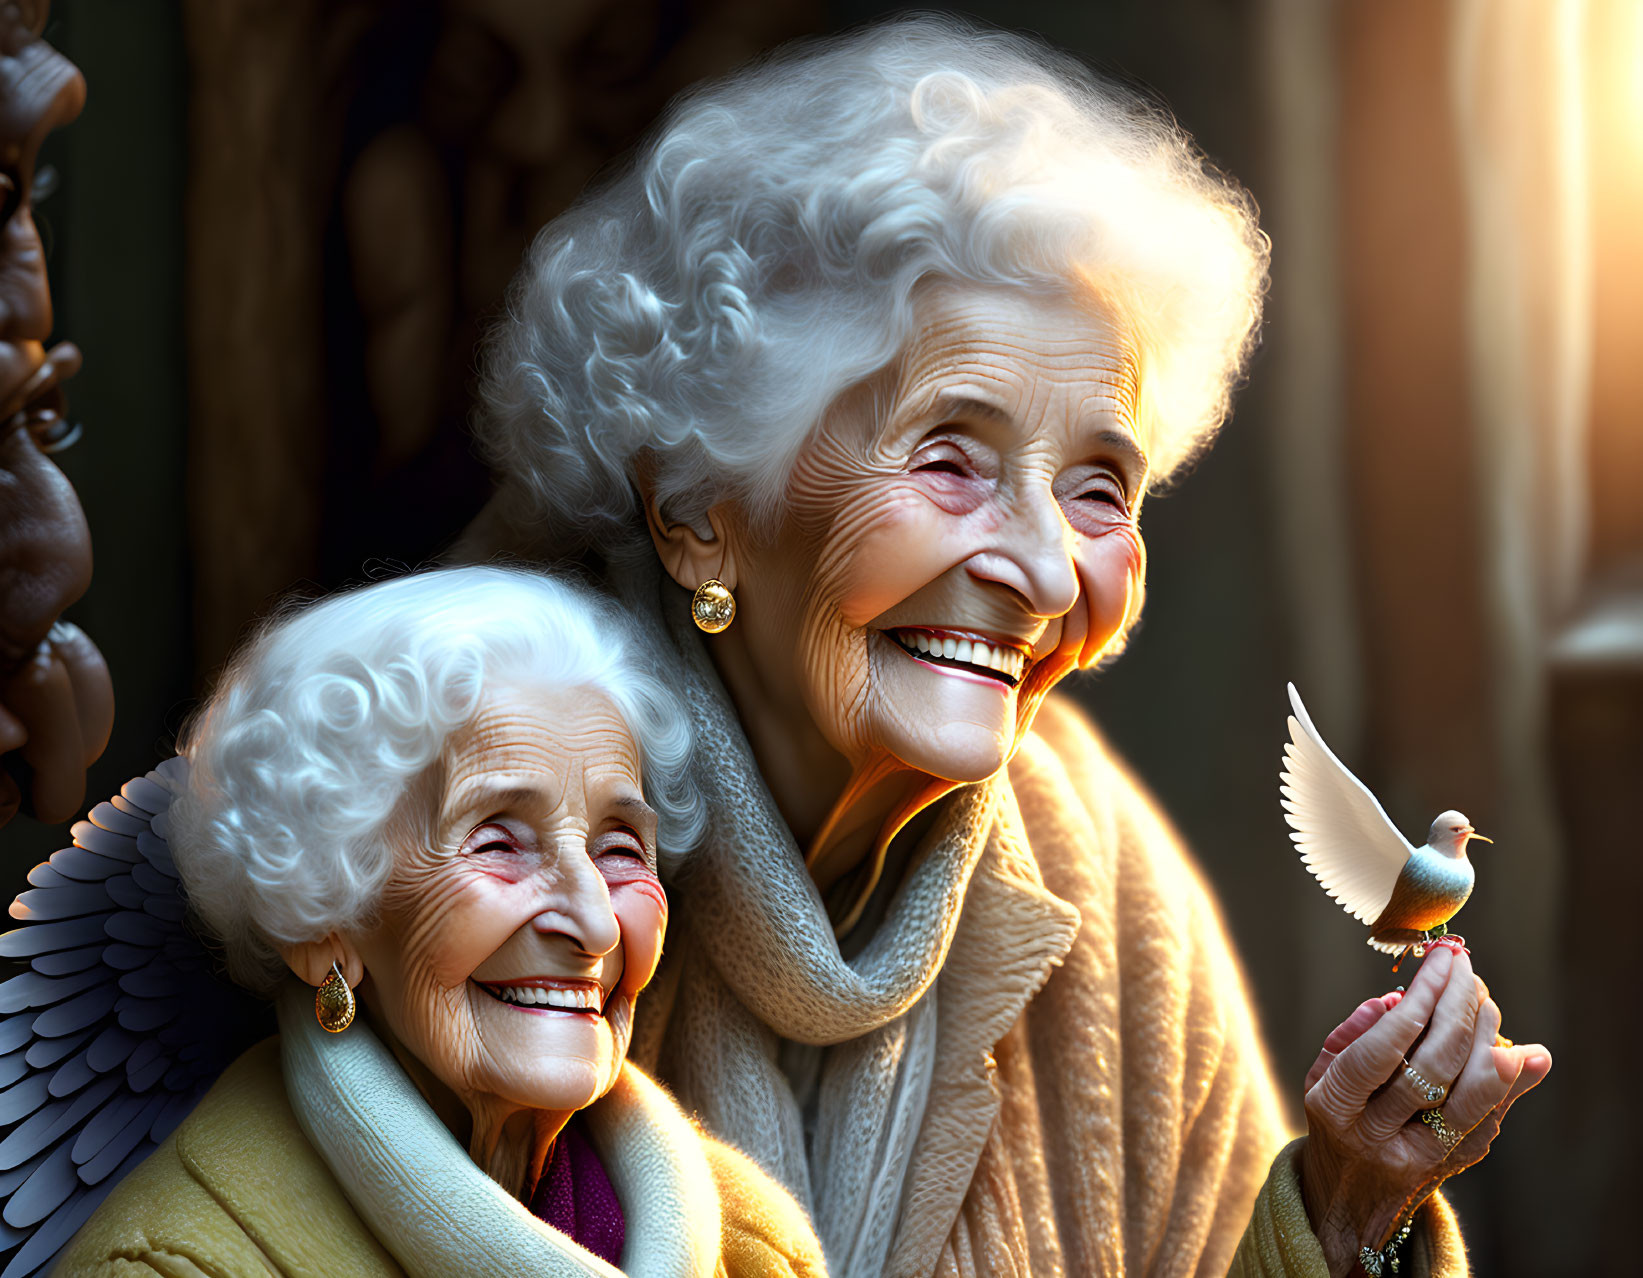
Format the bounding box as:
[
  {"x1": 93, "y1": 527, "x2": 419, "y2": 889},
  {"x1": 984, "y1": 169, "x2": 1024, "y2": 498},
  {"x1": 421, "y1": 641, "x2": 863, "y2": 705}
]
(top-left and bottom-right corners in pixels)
[{"x1": 58, "y1": 568, "x2": 822, "y2": 1278}]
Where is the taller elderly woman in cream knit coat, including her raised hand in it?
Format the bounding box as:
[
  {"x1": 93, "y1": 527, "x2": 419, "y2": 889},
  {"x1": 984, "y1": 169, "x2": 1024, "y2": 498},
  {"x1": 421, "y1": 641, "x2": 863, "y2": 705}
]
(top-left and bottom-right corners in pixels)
[{"x1": 465, "y1": 18, "x2": 1549, "y2": 1278}]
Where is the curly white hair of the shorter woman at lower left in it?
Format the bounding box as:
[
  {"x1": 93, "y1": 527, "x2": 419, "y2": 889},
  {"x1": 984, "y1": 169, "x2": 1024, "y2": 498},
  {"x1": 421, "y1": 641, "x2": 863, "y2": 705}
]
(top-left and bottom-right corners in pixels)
[{"x1": 169, "y1": 567, "x2": 705, "y2": 992}]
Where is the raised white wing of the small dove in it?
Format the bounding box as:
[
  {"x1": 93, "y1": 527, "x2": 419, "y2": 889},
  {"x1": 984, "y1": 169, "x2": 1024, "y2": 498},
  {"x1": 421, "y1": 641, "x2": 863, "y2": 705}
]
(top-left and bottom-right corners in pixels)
[{"x1": 1278, "y1": 683, "x2": 1415, "y2": 923}]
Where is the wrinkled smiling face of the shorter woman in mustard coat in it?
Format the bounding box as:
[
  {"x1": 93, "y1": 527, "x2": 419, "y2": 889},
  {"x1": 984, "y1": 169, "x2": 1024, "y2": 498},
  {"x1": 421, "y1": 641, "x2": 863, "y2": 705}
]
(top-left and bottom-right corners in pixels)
[{"x1": 358, "y1": 685, "x2": 667, "y2": 1110}]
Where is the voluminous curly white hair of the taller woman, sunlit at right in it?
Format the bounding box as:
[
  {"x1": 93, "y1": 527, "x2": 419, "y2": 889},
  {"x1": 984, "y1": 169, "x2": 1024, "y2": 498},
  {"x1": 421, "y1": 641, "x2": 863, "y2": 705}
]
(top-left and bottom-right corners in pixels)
[{"x1": 476, "y1": 15, "x2": 1267, "y2": 555}]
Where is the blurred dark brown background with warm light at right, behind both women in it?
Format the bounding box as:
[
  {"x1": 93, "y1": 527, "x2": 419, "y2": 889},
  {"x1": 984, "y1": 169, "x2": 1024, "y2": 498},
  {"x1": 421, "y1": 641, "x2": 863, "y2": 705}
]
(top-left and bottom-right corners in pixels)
[{"x1": 0, "y1": 0, "x2": 1643, "y2": 1275}]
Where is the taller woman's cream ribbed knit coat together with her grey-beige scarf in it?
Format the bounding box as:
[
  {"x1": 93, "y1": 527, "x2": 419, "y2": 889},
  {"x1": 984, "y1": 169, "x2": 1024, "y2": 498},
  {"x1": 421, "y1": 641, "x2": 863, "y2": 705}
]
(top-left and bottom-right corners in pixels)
[{"x1": 618, "y1": 575, "x2": 1464, "y2": 1278}]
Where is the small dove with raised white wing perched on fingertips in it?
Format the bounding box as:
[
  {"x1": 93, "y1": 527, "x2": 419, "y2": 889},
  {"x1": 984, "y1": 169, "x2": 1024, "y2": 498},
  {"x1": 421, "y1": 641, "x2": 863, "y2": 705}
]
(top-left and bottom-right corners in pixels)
[{"x1": 1278, "y1": 683, "x2": 1492, "y2": 971}]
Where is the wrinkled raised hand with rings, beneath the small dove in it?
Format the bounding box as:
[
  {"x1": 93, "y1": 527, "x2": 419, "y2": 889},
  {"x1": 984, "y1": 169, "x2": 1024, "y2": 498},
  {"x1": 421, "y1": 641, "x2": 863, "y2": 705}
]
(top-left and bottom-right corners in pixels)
[{"x1": 1301, "y1": 945, "x2": 1551, "y2": 1275}]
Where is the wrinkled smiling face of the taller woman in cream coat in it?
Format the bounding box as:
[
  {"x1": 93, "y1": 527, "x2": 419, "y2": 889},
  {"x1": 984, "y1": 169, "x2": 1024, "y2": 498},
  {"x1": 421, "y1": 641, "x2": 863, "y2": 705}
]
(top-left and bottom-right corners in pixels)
[{"x1": 736, "y1": 286, "x2": 1147, "y2": 780}]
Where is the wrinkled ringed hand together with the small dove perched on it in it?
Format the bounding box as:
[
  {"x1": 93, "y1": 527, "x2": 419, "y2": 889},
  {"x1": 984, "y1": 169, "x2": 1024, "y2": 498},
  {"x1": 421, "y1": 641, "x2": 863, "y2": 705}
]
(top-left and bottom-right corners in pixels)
[{"x1": 1282, "y1": 685, "x2": 1551, "y2": 1275}]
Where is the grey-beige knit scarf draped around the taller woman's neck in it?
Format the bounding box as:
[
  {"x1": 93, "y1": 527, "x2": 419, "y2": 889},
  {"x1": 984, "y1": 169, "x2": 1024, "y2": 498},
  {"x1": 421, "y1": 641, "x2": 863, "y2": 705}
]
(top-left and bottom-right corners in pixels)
[{"x1": 623, "y1": 577, "x2": 1076, "y2": 1278}]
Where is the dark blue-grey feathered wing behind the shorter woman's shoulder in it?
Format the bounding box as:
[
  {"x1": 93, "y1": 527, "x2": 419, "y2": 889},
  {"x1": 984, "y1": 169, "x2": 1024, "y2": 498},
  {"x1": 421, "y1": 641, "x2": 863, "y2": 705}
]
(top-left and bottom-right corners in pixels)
[{"x1": 0, "y1": 759, "x2": 273, "y2": 1278}]
